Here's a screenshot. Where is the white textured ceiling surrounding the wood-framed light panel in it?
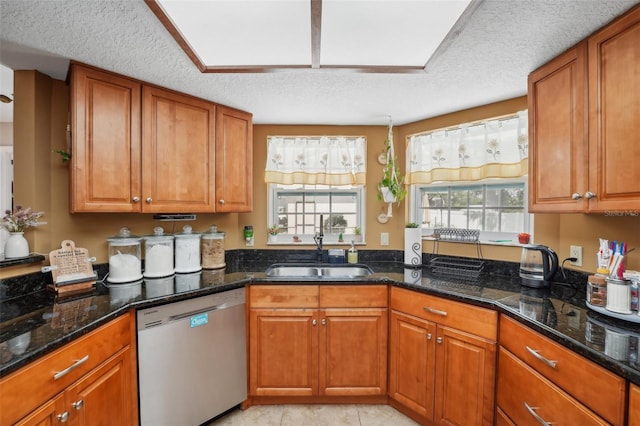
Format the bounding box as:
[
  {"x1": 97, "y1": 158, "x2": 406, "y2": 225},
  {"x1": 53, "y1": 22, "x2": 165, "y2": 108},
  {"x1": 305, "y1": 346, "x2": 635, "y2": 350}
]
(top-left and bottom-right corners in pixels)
[{"x1": 0, "y1": 0, "x2": 640, "y2": 125}]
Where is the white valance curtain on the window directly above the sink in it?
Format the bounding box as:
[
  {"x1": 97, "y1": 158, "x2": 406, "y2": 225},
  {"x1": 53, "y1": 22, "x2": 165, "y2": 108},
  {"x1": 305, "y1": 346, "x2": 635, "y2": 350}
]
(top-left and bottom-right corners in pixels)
[{"x1": 264, "y1": 136, "x2": 367, "y2": 185}]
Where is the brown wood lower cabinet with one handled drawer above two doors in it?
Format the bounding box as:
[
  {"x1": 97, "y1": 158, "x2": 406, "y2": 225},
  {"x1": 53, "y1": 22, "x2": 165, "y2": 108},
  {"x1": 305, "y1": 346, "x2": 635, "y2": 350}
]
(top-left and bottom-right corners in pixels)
[{"x1": 389, "y1": 288, "x2": 497, "y2": 425}]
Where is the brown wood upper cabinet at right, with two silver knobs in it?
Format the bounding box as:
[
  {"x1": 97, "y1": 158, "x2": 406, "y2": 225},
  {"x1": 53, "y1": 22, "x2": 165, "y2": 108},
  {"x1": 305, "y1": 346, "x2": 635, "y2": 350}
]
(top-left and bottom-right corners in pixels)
[{"x1": 529, "y1": 7, "x2": 640, "y2": 213}]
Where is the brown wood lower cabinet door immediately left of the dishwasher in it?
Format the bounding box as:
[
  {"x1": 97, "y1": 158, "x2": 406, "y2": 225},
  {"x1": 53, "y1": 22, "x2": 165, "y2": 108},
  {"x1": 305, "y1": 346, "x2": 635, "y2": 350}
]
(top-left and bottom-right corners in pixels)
[{"x1": 66, "y1": 348, "x2": 138, "y2": 426}]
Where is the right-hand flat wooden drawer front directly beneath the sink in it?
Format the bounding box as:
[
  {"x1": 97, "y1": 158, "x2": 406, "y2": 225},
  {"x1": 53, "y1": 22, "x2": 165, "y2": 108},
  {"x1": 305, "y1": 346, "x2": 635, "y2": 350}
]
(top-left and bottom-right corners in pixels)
[{"x1": 320, "y1": 285, "x2": 388, "y2": 308}]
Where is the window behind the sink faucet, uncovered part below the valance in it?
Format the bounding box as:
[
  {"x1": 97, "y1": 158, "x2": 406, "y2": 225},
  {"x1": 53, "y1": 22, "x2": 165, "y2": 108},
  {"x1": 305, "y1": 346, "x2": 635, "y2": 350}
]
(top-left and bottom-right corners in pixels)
[{"x1": 269, "y1": 184, "x2": 364, "y2": 244}]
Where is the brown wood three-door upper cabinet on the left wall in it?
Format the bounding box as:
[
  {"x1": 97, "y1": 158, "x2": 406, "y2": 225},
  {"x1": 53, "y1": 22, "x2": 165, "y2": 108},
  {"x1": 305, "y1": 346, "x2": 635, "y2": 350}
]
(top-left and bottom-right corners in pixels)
[{"x1": 70, "y1": 64, "x2": 253, "y2": 213}]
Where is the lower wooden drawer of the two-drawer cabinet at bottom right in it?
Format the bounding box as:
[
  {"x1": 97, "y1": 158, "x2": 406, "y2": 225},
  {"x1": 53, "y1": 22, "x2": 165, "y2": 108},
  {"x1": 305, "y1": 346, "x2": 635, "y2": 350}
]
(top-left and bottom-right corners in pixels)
[{"x1": 497, "y1": 347, "x2": 608, "y2": 426}]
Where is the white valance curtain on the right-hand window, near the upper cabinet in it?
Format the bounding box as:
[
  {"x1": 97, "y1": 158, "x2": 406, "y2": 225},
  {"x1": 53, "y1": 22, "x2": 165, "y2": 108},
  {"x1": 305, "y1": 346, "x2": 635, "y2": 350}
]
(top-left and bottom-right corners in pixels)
[{"x1": 406, "y1": 111, "x2": 529, "y2": 184}]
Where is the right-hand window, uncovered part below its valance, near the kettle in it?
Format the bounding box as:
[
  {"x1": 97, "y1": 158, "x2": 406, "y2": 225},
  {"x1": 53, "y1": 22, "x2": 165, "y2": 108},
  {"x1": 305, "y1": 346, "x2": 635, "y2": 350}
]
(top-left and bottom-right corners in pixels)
[{"x1": 412, "y1": 180, "x2": 530, "y2": 242}]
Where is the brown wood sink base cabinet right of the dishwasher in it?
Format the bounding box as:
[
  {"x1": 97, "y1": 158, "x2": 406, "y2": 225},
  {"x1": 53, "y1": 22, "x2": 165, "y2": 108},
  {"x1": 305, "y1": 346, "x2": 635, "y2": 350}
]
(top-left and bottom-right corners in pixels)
[{"x1": 249, "y1": 285, "x2": 387, "y2": 397}]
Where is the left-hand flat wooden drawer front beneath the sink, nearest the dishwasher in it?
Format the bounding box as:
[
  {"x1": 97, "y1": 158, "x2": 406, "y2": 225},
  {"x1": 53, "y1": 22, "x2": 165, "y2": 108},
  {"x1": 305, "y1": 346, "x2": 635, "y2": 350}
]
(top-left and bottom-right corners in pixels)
[{"x1": 249, "y1": 285, "x2": 318, "y2": 308}]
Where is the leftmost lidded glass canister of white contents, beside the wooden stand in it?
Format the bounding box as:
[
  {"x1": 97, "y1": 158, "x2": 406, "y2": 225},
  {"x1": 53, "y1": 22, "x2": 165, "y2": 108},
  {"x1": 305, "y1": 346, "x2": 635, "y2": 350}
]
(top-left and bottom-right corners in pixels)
[{"x1": 107, "y1": 226, "x2": 142, "y2": 283}]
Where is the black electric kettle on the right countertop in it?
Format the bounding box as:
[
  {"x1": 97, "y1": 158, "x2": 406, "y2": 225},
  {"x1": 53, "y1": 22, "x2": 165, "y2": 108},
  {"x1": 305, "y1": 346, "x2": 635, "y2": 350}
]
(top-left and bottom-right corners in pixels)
[{"x1": 520, "y1": 244, "x2": 558, "y2": 288}]
